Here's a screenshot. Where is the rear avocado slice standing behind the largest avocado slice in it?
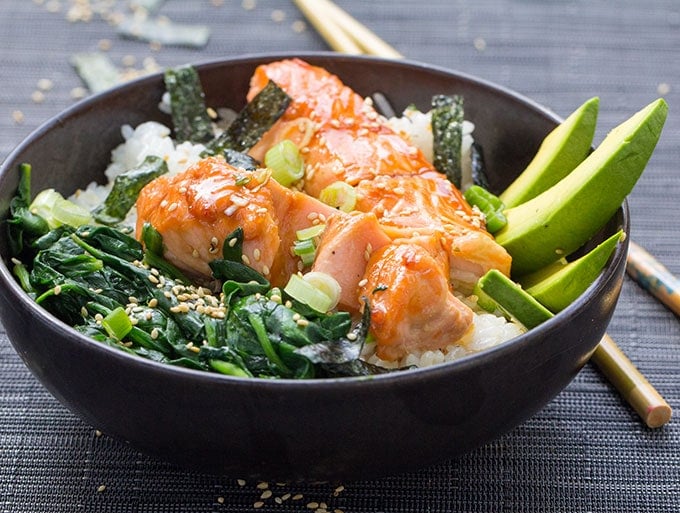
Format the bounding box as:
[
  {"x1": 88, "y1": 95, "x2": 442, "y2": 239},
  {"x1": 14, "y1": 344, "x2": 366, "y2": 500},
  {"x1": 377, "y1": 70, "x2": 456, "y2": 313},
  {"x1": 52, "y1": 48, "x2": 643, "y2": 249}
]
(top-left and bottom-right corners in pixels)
[{"x1": 500, "y1": 97, "x2": 600, "y2": 208}]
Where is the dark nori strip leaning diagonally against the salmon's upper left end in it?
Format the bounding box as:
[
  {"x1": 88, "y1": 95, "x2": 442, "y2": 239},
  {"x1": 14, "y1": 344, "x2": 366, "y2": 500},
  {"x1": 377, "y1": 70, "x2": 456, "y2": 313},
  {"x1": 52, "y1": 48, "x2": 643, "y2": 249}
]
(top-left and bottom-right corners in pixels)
[{"x1": 204, "y1": 80, "x2": 291, "y2": 155}]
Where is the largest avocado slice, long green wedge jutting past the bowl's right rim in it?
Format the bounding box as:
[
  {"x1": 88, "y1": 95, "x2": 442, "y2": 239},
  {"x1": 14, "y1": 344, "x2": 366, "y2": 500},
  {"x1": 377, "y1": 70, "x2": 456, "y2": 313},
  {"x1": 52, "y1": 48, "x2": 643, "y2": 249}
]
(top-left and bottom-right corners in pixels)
[{"x1": 495, "y1": 98, "x2": 668, "y2": 278}]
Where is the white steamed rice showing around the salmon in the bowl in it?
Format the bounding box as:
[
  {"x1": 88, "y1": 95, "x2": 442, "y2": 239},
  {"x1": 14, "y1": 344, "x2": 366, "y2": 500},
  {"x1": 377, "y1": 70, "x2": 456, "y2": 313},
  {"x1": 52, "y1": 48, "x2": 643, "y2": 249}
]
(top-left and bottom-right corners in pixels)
[{"x1": 69, "y1": 108, "x2": 525, "y2": 368}]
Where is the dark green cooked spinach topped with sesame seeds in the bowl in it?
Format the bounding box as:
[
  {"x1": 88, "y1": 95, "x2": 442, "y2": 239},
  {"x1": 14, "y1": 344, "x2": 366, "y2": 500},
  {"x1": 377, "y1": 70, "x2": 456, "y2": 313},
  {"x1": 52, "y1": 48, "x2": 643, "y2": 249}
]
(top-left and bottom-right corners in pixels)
[{"x1": 8, "y1": 166, "x2": 385, "y2": 379}]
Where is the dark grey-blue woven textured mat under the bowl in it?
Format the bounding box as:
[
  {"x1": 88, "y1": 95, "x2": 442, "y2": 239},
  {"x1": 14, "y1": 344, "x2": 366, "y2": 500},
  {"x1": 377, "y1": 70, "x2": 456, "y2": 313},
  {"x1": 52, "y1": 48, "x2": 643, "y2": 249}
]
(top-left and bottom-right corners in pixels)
[{"x1": 0, "y1": 0, "x2": 680, "y2": 513}]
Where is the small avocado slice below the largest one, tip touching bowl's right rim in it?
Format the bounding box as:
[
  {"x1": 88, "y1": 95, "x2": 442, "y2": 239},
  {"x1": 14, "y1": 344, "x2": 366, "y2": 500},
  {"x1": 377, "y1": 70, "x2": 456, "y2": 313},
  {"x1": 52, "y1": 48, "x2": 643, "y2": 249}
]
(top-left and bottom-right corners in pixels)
[{"x1": 519, "y1": 230, "x2": 625, "y2": 313}]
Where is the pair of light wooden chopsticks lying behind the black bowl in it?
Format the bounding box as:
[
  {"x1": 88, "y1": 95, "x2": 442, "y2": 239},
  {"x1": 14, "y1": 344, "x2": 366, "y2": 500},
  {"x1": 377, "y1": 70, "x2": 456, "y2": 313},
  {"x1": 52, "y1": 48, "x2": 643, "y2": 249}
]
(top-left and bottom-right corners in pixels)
[{"x1": 293, "y1": 0, "x2": 680, "y2": 428}]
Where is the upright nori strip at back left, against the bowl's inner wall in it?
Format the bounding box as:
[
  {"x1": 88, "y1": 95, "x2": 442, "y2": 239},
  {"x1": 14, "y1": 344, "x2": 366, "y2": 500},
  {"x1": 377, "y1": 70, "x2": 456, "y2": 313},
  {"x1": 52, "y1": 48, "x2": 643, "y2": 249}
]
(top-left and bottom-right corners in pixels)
[{"x1": 165, "y1": 66, "x2": 213, "y2": 143}]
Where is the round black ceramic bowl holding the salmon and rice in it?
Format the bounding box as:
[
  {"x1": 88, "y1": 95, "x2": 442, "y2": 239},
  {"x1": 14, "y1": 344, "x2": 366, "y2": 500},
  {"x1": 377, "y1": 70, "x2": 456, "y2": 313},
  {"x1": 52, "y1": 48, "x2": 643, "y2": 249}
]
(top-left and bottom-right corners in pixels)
[{"x1": 0, "y1": 53, "x2": 629, "y2": 479}]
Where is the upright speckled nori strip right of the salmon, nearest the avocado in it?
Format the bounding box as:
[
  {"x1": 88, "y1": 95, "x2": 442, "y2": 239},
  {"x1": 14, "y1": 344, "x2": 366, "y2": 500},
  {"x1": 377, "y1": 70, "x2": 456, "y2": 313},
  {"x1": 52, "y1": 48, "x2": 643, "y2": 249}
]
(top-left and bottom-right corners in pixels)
[{"x1": 431, "y1": 94, "x2": 463, "y2": 187}]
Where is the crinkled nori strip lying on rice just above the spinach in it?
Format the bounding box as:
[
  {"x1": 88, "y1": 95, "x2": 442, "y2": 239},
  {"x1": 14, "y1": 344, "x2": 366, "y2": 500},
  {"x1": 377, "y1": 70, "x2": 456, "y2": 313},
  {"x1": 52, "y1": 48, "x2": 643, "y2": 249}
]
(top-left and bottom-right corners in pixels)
[{"x1": 92, "y1": 155, "x2": 168, "y2": 224}]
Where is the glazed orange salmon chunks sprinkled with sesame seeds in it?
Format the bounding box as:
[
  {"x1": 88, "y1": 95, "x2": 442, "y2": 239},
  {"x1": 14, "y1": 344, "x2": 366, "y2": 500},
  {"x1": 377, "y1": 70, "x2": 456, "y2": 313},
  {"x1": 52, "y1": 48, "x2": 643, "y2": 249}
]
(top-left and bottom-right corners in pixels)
[{"x1": 137, "y1": 59, "x2": 511, "y2": 360}]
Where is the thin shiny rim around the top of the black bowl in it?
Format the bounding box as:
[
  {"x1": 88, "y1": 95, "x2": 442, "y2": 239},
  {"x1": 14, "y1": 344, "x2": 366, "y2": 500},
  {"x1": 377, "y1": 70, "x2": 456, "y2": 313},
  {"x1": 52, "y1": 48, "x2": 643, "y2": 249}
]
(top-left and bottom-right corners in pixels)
[{"x1": 0, "y1": 51, "x2": 630, "y2": 390}]
